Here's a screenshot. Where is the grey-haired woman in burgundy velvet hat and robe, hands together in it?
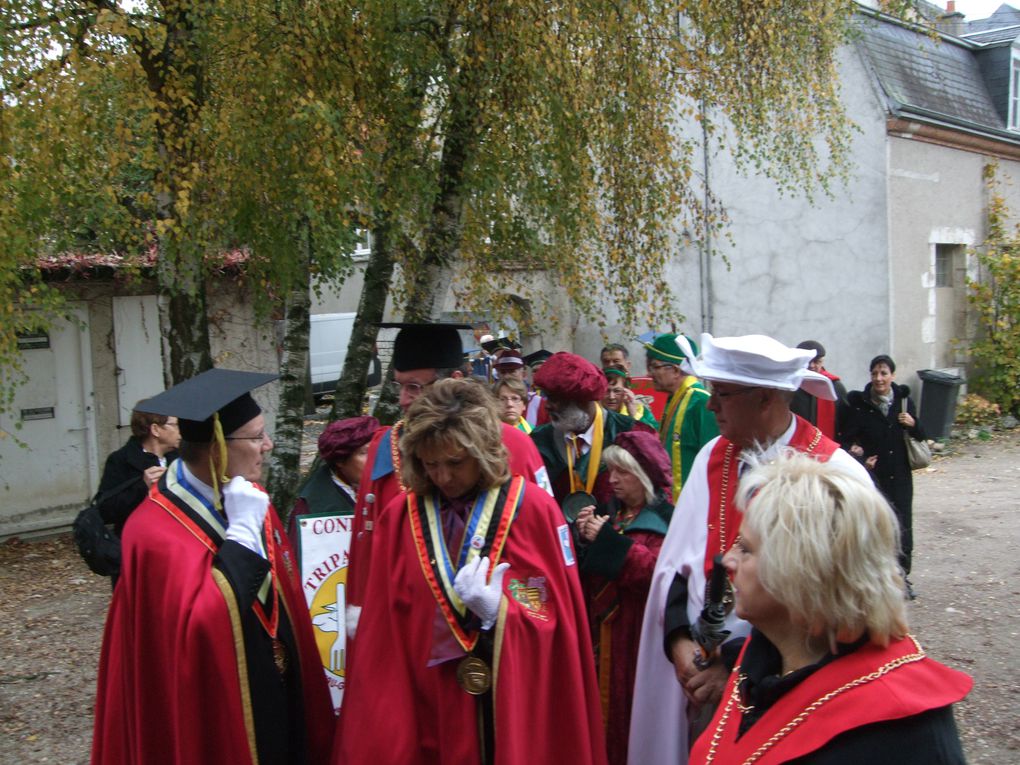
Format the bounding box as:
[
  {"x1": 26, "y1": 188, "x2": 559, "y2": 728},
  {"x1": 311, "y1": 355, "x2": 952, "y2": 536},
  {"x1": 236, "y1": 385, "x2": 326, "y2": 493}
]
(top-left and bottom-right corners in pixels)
[{"x1": 576, "y1": 430, "x2": 673, "y2": 765}]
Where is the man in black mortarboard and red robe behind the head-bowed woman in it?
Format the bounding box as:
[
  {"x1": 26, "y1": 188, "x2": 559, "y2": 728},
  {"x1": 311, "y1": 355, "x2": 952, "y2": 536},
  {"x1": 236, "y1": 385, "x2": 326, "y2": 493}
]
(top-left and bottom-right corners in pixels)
[{"x1": 347, "y1": 322, "x2": 552, "y2": 640}]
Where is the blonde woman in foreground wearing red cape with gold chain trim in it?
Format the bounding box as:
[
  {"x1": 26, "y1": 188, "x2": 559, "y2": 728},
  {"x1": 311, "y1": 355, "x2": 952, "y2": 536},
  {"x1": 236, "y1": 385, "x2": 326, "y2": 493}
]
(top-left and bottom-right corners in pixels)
[{"x1": 691, "y1": 455, "x2": 973, "y2": 765}]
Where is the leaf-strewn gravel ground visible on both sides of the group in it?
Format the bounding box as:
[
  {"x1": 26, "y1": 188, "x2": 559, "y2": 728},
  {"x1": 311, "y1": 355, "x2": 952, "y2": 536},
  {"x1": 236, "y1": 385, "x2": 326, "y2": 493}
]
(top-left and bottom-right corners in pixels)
[{"x1": 0, "y1": 428, "x2": 1020, "y2": 765}]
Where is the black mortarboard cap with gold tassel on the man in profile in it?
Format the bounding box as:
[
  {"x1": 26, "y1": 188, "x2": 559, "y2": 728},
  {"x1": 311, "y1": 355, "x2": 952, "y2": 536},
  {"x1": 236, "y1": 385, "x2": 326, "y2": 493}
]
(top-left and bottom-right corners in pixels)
[{"x1": 135, "y1": 369, "x2": 279, "y2": 444}]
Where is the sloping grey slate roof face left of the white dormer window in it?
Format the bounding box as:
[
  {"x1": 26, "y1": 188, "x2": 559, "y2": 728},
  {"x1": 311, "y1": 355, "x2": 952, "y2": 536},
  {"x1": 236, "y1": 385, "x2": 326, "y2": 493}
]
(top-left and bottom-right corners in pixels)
[{"x1": 860, "y1": 17, "x2": 1007, "y2": 131}]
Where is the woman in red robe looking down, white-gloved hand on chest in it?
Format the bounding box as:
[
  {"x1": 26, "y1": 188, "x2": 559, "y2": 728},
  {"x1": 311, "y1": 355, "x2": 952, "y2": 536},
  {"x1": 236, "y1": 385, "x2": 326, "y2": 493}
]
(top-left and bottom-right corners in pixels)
[{"x1": 333, "y1": 379, "x2": 606, "y2": 765}]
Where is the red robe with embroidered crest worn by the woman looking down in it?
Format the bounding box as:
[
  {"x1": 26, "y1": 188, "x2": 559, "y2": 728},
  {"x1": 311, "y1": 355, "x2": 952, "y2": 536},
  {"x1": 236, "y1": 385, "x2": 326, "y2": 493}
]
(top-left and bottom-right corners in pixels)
[{"x1": 333, "y1": 482, "x2": 606, "y2": 765}]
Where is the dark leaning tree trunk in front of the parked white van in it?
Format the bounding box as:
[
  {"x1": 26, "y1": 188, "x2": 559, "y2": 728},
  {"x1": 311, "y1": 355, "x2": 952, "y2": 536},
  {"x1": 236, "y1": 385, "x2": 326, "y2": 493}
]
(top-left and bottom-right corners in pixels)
[{"x1": 329, "y1": 216, "x2": 400, "y2": 424}]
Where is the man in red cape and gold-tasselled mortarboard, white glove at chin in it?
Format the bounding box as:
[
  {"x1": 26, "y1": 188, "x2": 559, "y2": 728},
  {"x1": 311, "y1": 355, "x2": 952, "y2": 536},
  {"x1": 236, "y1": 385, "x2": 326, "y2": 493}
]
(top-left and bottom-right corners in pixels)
[{"x1": 92, "y1": 369, "x2": 334, "y2": 765}]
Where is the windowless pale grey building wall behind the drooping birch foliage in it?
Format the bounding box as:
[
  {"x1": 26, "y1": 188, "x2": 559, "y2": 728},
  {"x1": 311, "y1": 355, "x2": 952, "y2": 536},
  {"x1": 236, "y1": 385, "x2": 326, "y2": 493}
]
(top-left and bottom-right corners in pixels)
[{"x1": 591, "y1": 48, "x2": 889, "y2": 387}]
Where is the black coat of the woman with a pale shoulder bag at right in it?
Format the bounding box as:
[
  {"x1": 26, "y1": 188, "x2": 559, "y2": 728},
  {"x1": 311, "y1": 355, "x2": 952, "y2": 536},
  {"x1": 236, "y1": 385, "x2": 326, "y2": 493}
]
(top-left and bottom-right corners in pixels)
[{"x1": 839, "y1": 383, "x2": 925, "y2": 517}]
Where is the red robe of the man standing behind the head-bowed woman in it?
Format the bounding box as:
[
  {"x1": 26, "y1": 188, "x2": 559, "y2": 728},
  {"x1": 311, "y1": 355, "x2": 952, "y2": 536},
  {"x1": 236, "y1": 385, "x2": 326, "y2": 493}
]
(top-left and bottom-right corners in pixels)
[{"x1": 347, "y1": 420, "x2": 546, "y2": 607}]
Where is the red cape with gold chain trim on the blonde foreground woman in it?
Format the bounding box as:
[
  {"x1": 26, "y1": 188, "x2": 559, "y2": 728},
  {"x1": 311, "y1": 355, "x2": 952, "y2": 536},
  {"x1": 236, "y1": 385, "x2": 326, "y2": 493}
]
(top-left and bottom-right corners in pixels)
[{"x1": 690, "y1": 635, "x2": 973, "y2": 765}]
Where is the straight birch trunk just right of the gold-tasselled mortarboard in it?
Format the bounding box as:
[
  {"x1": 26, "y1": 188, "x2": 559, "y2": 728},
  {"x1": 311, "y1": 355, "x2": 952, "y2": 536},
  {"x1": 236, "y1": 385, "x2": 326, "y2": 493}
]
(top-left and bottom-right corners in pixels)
[{"x1": 266, "y1": 221, "x2": 312, "y2": 523}]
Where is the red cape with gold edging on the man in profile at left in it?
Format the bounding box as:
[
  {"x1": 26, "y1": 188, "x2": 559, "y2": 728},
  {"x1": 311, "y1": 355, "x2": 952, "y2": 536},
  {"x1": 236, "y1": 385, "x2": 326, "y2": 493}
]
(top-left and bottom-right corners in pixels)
[{"x1": 92, "y1": 465, "x2": 335, "y2": 765}]
